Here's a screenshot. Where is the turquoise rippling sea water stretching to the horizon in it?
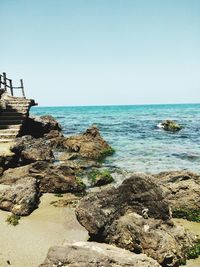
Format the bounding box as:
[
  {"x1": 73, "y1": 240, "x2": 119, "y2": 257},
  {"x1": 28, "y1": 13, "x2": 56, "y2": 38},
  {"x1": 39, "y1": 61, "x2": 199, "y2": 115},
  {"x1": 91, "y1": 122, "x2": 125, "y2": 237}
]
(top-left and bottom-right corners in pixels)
[{"x1": 31, "y1": 104, "x2": 200, "y2": 175}]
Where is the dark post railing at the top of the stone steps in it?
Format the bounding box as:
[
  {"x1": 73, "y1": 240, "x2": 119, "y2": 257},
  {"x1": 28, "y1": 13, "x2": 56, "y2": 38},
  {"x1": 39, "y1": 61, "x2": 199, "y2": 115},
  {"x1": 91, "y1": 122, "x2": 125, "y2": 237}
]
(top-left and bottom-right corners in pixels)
[{"x1": 0, "y1": 72, "x2": 25, "y2": 98}]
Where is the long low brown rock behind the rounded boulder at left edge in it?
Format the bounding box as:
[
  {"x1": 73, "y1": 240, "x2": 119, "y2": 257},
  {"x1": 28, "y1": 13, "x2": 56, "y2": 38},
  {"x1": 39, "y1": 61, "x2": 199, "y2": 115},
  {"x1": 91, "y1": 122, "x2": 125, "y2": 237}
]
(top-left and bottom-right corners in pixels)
[{"x1": 0, "y1": 161, "x2": 85, "y2": 193}]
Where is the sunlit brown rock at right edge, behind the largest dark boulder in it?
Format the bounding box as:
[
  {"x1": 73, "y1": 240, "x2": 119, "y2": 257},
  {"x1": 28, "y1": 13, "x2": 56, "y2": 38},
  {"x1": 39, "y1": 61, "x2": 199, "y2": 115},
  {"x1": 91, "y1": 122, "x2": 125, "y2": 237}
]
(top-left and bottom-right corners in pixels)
[{"x1": 154, "y1": 171, "x2": 200, "y2": 213}]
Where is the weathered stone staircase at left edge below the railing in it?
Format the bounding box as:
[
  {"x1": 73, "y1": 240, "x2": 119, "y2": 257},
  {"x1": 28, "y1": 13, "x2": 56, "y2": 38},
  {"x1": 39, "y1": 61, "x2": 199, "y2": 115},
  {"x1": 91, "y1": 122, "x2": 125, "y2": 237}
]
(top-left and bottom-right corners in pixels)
[{"x1": 0, "y1": 93, "x2": 36, "y2": 143}]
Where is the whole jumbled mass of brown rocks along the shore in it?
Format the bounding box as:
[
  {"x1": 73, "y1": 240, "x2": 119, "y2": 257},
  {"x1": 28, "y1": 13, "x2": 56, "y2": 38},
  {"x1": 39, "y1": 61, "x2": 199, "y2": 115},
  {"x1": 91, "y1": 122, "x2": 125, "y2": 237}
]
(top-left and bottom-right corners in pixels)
[{"x1": 0, "y1": 116, "x2": 200, "y2": 267}]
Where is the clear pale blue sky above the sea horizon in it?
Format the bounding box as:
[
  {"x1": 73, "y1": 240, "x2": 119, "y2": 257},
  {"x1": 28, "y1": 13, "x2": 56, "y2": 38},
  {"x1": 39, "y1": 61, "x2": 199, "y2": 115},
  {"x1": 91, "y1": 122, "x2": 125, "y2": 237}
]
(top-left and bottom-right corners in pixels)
[{"x1": 0, "y1": 0, "x2": 200, "y2": 106}]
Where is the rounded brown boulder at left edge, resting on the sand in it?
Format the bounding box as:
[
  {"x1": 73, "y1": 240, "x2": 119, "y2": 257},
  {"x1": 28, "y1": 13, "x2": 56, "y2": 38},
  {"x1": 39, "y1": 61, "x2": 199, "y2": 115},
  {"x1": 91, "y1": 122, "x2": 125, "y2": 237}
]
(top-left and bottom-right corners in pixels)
[{"x1": 0, "y1": 177, "x2": 39, "y2": 215}]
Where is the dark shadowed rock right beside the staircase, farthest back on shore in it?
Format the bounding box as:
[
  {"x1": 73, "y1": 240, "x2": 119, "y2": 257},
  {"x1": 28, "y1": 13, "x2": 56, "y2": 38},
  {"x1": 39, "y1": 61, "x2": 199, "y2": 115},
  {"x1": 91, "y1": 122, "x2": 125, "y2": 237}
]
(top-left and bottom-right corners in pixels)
[{"x1": 21, "y1": 115, "x2": 61, "y2": 138}]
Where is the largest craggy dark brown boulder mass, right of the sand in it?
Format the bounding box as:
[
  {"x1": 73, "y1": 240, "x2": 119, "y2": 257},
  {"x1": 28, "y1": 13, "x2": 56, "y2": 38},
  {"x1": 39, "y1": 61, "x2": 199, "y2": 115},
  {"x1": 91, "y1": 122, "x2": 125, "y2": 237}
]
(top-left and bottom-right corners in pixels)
[{"x1": 76, "y1": 175, "x2": 196, "y2": 266}]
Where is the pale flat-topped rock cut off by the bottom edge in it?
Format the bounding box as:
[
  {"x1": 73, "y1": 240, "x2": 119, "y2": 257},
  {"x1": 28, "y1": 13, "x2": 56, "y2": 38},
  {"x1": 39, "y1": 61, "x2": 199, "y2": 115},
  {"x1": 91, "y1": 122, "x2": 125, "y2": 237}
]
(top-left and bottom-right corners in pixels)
[{"x1": 40, "y1": 242, "x2": 160, "y2": 267}]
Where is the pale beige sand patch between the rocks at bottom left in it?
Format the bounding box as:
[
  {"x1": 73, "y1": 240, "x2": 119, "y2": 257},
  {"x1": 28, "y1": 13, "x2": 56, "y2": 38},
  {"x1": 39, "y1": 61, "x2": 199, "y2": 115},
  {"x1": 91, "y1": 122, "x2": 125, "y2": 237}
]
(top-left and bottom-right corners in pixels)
[{"x1": 0, "y1": 194, "x2": 88, "y2": 267}]
